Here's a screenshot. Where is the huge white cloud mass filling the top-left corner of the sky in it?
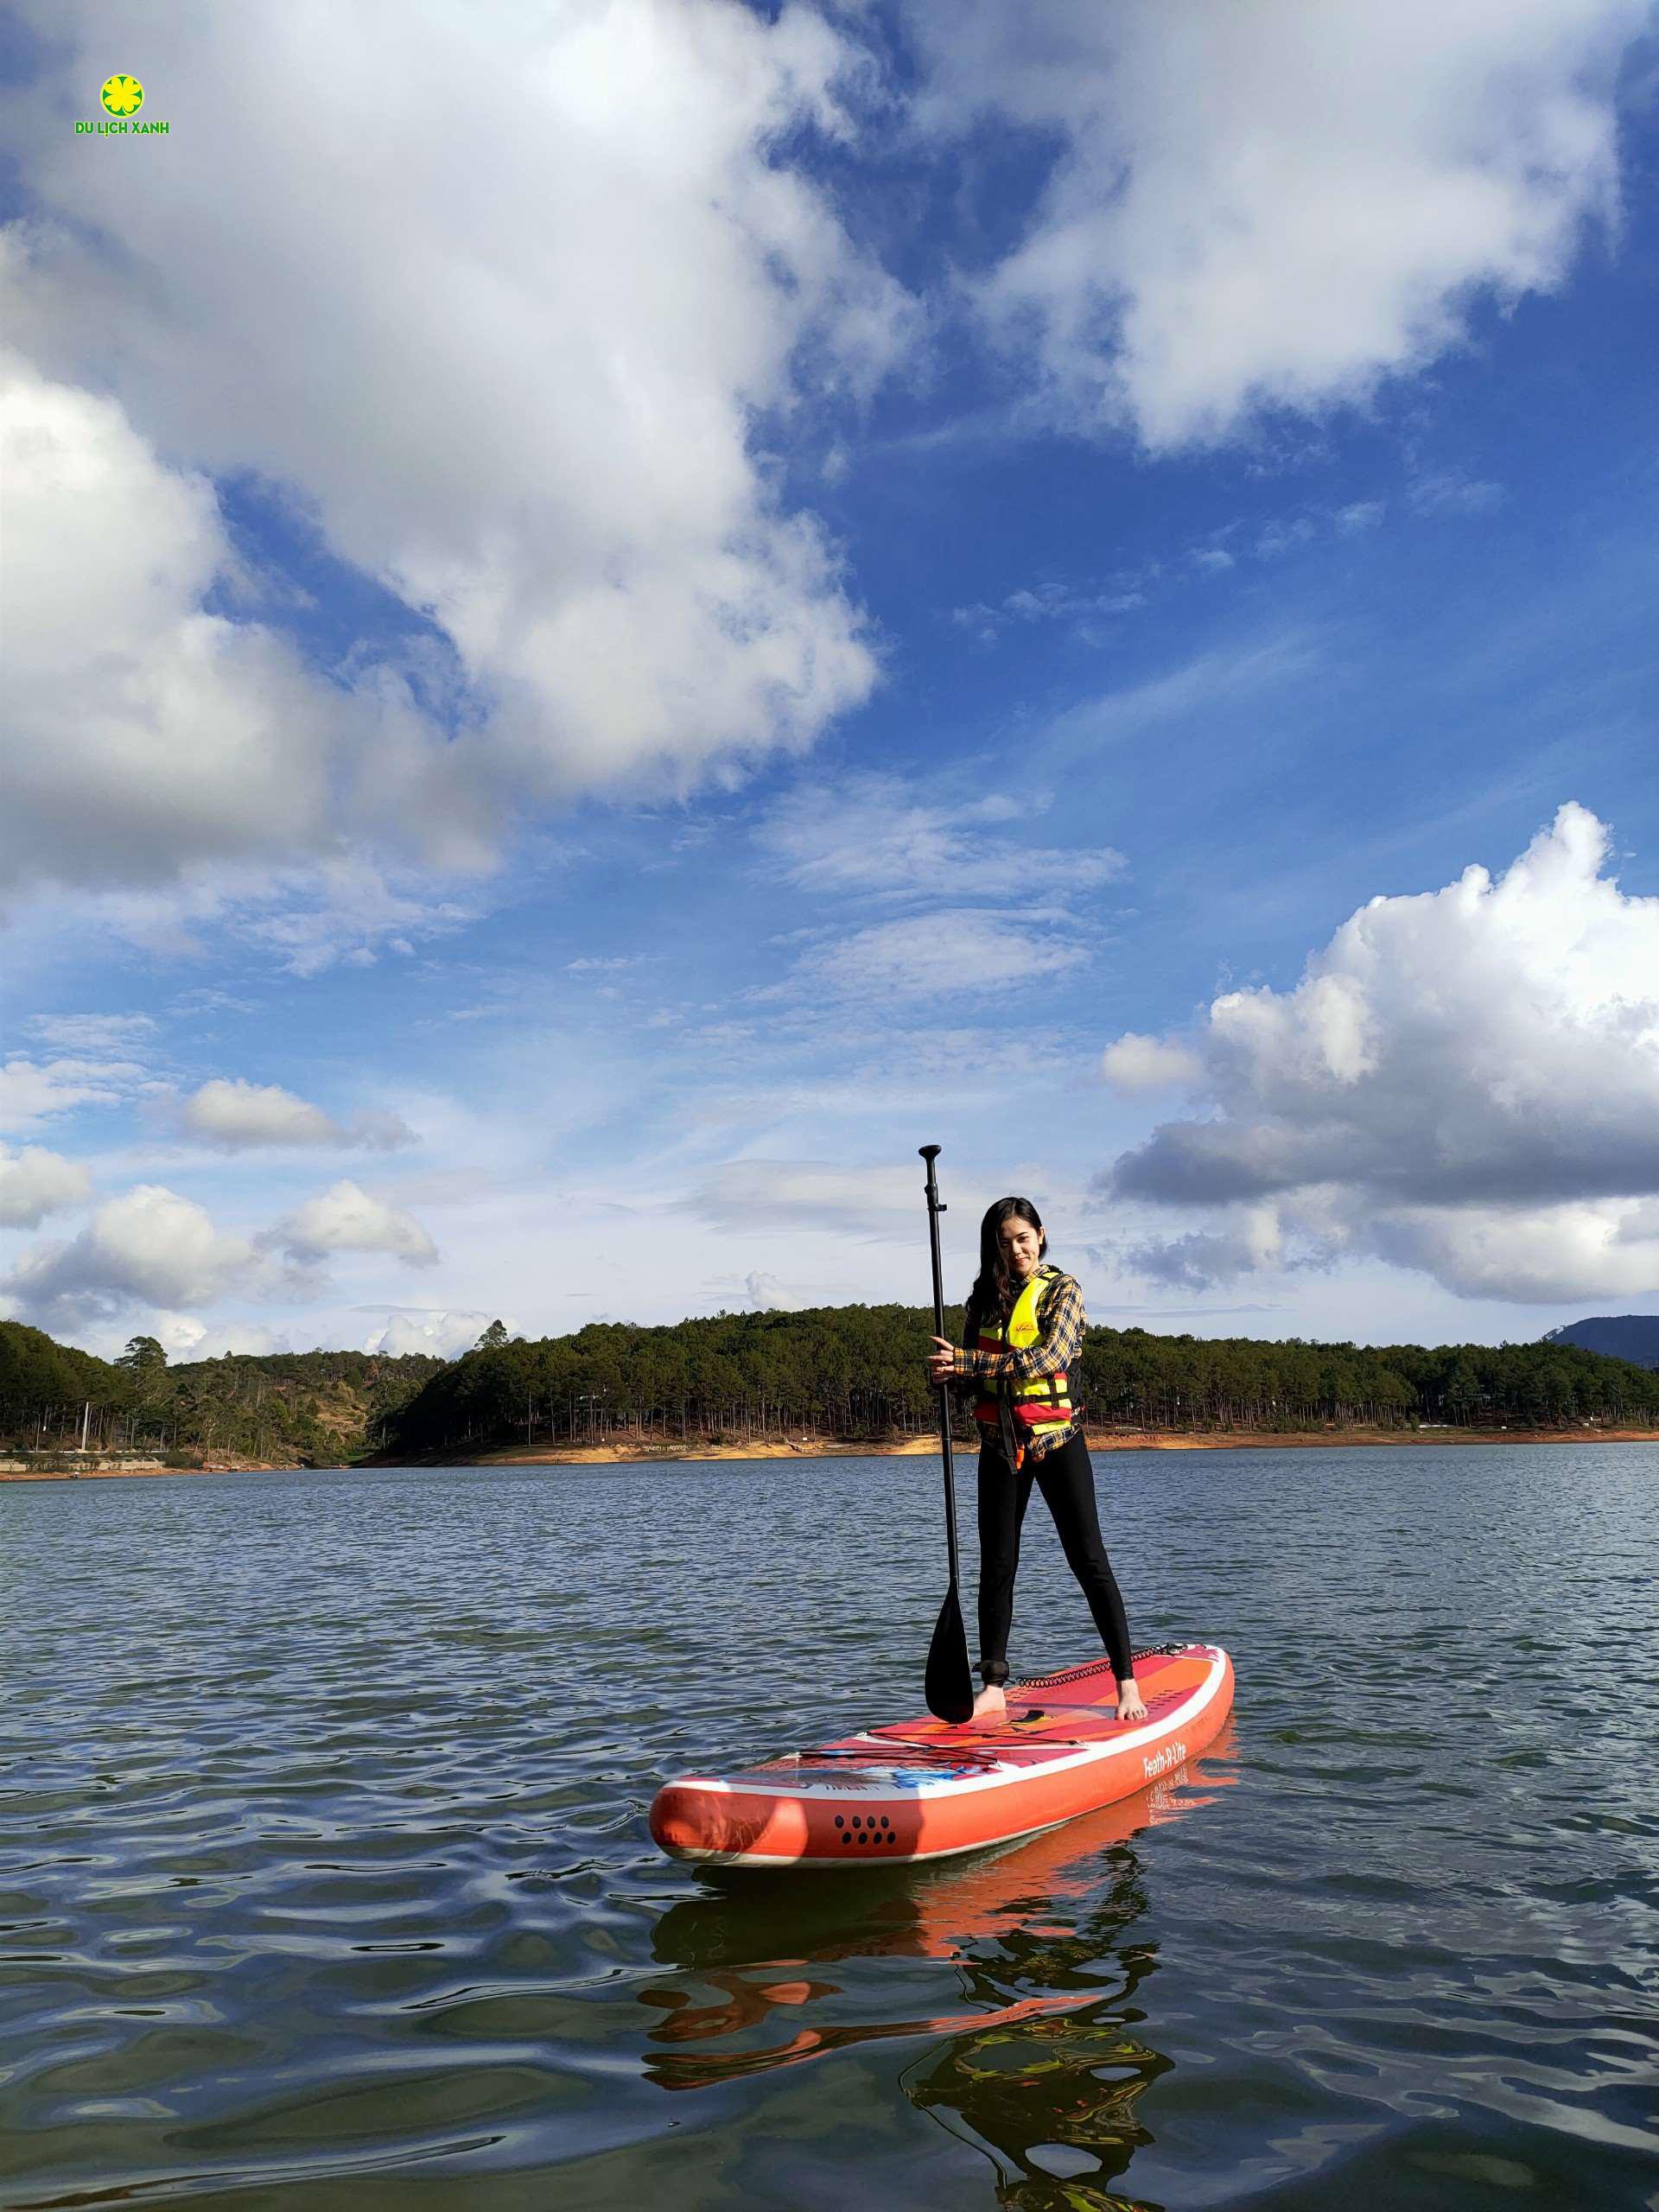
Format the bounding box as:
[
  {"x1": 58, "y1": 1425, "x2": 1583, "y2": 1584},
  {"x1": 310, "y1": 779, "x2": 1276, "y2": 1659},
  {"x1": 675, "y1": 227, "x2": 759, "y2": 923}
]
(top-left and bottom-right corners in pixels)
[{"x1": 0, "y1": 0, "x2": 909, "y2": 882}]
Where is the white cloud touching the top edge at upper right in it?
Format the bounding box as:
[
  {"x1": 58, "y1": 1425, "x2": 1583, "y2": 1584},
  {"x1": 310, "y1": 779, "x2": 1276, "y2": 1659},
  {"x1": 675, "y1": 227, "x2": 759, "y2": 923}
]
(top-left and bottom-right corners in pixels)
[{"x1": 913, "y1": 0, "x2": 1648, "y2": 447}]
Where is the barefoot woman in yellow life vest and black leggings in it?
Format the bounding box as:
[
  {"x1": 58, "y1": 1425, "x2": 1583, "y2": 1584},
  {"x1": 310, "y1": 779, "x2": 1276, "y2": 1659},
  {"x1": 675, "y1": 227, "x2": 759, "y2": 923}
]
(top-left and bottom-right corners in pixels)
[{"x1": 927, "y1": 1199, "x2": 1146, "y2": 1721}]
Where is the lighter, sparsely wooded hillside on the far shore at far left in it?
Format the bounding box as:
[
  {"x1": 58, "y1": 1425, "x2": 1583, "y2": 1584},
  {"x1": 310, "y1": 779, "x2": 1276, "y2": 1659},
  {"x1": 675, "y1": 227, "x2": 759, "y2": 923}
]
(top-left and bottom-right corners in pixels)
[{"x1": 0, "y1": 1320, "x2": 442, "y2": 1466}]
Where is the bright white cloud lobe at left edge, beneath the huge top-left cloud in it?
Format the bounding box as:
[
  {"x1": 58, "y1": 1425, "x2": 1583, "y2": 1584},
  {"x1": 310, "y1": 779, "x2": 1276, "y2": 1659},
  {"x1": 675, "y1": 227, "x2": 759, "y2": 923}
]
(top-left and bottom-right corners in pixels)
[{"x1": 0, "y1": 354, "x2": 491, "y2": 889}]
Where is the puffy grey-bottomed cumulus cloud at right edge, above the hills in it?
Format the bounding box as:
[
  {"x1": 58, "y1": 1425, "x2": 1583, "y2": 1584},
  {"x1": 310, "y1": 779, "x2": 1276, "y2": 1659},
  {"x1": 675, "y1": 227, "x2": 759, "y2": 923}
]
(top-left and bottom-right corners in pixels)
[{"x1": 1109, "y1": 805, "x2": 1659, "y2": 1300}]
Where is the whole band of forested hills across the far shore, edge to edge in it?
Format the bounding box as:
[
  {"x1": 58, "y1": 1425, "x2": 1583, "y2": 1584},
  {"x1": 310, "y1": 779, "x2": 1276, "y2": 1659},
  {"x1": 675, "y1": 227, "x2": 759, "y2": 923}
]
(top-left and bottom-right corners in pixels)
[{"x1": 0, "y1": 1305, "x2": 1659, "y2": 1466}]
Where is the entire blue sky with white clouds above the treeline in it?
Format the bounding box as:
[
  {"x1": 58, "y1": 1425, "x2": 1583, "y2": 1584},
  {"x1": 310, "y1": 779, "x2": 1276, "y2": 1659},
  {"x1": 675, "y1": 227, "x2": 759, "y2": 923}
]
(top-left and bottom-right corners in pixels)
[{"x1": 0, "y1": 0, "x2": 1659, "y2": 1354}]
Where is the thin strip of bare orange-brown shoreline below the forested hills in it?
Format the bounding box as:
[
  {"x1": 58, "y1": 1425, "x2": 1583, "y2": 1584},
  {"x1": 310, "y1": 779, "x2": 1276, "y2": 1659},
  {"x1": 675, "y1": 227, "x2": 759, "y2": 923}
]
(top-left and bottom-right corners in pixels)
[{"x1": 0, "y1": 1427, "x2": 1659, "y2": 1482}]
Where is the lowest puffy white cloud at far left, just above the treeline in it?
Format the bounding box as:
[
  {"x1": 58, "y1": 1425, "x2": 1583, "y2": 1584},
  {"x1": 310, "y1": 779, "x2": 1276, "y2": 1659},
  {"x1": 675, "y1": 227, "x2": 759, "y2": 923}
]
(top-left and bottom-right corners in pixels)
[{"x1": 7, "y1": 1184, "x2": 257, "y2": 1330}]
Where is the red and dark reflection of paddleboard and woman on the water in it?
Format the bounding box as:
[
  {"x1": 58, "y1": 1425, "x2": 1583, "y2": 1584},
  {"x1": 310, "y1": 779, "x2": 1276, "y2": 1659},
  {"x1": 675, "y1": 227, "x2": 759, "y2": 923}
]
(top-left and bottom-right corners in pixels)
[{"x1": 639, "y1": 1727, "x2": 1232, "y2": 2212}]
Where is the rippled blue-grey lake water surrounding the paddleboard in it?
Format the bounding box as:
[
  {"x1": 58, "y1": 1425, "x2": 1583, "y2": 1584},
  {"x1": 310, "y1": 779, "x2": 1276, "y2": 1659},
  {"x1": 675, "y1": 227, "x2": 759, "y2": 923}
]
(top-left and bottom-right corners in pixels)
[{"x1": 0, "y1": 1445, "x2": 1659, "y2": 2212}]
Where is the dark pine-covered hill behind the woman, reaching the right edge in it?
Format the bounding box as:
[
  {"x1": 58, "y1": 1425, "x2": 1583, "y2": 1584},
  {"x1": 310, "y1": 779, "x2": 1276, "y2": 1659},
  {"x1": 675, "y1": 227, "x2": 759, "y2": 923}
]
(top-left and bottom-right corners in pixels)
[{"x1": 387, "y1": 1305, "x2": 1659, "y2": 1453}]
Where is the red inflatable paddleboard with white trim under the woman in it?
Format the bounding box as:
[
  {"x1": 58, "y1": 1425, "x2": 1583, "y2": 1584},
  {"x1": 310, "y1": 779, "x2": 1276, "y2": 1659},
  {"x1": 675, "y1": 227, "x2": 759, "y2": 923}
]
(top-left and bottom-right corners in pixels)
[{"x1": 651, "y1": 1643, "x2": 1232, "y2": 1867}]
